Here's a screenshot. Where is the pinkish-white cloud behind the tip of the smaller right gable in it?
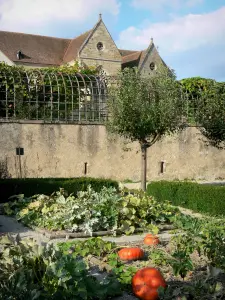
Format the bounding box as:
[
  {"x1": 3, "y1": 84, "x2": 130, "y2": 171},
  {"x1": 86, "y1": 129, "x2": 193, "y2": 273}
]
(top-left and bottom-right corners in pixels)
[{"x1": 117, "y1": 7, "x2": 225, "y2": 53}]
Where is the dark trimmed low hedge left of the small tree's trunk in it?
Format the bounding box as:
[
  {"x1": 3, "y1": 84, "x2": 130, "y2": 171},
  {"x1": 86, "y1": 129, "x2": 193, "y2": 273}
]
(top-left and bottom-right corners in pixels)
[{"x1": 0, "y1": 177, "x2": 119, "y2": 203}]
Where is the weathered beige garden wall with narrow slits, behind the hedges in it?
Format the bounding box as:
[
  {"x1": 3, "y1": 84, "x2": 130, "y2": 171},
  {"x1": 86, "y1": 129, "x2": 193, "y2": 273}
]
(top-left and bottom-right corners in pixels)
[{"x1": 0, "y1": 122, "x2": 225, "y2": 181}]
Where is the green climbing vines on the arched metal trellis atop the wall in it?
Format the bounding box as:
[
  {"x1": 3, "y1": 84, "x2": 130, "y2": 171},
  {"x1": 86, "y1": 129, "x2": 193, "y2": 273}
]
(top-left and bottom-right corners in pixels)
[{"x1": 0, "y1": 62, "x2": 98, "y2": 121}]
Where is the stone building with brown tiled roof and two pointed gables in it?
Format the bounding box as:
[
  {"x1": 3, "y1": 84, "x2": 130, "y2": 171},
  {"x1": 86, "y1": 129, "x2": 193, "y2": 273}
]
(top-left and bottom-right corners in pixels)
[{"x1": 0, "y1": 14, "x2": 165, "y2": 76}]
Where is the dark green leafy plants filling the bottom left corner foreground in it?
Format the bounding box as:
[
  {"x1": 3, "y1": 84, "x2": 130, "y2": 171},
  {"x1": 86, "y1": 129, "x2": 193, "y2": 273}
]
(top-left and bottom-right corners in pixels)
[{"x1": 0, "y1": 236, "x2": 120, "y2": 300}]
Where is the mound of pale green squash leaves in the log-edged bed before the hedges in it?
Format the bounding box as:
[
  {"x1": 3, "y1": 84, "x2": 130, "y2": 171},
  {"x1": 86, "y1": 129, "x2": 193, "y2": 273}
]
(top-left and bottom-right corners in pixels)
[{"x1": 3, "y1": 186, "x2": 179, "y2": 234}]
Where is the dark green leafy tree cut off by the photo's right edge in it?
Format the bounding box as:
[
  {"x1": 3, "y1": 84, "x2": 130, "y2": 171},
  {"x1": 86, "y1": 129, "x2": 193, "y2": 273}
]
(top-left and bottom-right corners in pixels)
[{"x1": 180, "y1": 77, "x2": 225, "y2": 148}]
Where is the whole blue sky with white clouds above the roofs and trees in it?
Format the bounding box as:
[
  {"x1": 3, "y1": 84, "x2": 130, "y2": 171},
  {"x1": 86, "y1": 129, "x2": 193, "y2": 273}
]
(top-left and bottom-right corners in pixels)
[{"x1": 0, "y1": 0, "x2": 225, "y2": 81}]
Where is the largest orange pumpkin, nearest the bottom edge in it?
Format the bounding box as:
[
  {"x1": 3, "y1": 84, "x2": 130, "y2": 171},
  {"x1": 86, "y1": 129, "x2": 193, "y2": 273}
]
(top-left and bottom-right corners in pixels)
[{"x1": 132, "y1": 268, "x2": 166, "y2": 300}]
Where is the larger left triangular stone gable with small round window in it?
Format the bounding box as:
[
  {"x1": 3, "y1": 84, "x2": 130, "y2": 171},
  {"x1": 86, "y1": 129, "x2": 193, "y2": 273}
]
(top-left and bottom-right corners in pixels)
[{"x1": 79, "y1": 19, "x2": 121, "y2": 63}]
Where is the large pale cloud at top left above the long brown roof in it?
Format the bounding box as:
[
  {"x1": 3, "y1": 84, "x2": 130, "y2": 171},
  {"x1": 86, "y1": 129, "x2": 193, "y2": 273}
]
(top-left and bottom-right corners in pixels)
[{"x1": 0, "y1": 0, "x2": 120, "y2": 32}]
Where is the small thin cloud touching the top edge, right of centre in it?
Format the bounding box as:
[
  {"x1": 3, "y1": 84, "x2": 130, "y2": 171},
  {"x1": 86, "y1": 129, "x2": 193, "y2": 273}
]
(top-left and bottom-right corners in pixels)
[{"x1": 131, "y1": 0, "x2": 204, "y2": 11}]
